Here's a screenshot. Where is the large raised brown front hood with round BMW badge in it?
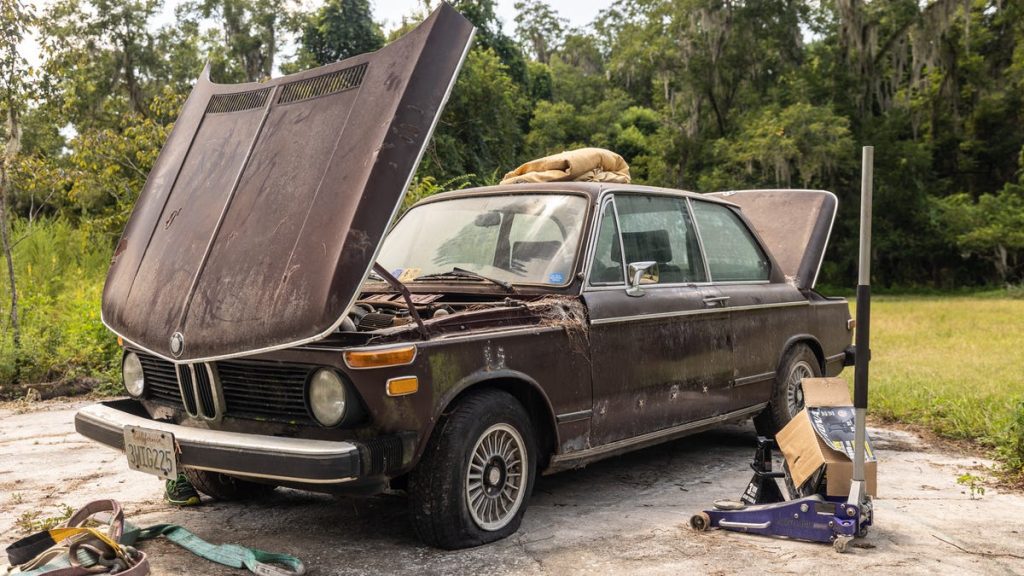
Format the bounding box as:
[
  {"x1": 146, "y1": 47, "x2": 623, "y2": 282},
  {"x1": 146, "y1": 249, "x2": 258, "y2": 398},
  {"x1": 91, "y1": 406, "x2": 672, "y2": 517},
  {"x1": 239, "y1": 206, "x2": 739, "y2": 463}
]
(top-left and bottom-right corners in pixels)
[{"x1": 102, "y1": 3, "x2": 473, "y2": 363}]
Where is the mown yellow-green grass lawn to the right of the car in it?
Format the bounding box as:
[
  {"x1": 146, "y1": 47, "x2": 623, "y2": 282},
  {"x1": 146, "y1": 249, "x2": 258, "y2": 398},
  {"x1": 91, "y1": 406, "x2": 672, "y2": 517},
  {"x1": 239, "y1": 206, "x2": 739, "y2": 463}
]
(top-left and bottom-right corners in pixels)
[{"x1": 846, "y1": 294, "x2": 1024, "y2": 471}]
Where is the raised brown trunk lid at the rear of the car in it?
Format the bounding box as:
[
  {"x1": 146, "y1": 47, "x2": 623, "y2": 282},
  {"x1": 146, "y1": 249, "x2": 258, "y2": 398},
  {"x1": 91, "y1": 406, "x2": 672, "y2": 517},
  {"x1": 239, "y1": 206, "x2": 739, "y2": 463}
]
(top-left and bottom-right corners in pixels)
[{"x1": 708, "y1": 190, "x2": 839, "y2": 290}]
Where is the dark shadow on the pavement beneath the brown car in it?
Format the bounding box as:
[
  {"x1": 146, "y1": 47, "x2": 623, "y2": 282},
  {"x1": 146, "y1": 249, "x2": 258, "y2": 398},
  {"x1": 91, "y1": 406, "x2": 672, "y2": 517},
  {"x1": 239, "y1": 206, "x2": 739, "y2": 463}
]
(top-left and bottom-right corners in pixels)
[{"x1": 148, "y1": 423, "x2": 756, "y2": 574}]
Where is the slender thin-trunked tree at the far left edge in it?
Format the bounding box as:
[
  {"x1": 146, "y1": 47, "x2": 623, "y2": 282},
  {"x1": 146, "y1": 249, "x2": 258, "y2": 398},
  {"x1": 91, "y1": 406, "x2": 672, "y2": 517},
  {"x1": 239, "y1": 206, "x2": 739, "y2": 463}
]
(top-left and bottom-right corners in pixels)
[{"x1": 0, "y1": 0, "x2": 35, "y2": 384}]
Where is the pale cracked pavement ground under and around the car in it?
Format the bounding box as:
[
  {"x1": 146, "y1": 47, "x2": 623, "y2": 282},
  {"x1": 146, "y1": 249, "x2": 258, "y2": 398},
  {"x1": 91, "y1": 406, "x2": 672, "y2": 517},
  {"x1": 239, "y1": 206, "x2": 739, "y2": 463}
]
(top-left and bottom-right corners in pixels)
[{"x1": 0, "y1": 401, "x2": 1024, "y2": 576}]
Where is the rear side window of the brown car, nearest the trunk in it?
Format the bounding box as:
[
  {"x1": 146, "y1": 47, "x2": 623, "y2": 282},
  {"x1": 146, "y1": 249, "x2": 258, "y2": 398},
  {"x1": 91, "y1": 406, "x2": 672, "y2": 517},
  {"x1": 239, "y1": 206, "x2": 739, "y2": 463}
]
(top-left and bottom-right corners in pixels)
[{"x1": 693, "y1": 201, "x2": 771, "y2": 282}]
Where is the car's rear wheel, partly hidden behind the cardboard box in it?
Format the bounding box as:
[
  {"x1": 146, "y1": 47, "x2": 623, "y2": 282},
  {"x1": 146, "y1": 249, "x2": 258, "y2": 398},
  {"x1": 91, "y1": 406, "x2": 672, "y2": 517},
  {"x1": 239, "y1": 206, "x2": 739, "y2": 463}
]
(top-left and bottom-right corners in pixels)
[{"x1": 754, "y1": 344, "x2": 821, "y2": 438}]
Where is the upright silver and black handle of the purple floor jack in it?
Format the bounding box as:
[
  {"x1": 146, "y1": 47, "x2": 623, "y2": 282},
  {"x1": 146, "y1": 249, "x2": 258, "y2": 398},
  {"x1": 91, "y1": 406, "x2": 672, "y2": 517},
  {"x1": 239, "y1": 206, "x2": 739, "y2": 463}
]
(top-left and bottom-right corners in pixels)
[{"x1": 848, "y1": 146, "x2": 874, "y2": 505}]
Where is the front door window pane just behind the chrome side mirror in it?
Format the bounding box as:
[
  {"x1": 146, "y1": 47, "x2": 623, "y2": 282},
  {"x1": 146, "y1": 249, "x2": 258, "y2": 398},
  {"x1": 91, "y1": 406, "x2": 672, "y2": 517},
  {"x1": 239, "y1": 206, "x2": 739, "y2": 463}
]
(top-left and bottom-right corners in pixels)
[{"x1": 611, "y1": 194, "x2": 707, "y2": 284}]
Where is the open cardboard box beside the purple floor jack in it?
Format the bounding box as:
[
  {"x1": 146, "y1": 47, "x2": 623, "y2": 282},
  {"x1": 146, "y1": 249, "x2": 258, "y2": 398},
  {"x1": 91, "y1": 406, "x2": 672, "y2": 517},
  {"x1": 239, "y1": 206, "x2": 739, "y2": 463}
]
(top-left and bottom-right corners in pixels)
[{"x1": 775, "y1": 378, "x2": 878, "y2": 496}]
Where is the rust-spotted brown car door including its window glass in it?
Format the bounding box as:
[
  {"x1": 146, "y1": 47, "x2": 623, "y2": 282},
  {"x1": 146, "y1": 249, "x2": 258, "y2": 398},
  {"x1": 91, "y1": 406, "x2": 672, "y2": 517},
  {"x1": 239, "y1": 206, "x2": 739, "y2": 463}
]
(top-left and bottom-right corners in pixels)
[{"x1": 584, "y1": 193, "x2": 732, "y2": 445}]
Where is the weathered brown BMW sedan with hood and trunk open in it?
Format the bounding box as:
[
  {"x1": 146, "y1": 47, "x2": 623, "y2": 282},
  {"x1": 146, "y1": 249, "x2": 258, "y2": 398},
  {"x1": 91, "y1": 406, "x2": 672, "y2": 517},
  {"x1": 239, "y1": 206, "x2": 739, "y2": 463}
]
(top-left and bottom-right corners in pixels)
[{"x1": 76, "y1": 5, "x2": 852, "y2": 548}]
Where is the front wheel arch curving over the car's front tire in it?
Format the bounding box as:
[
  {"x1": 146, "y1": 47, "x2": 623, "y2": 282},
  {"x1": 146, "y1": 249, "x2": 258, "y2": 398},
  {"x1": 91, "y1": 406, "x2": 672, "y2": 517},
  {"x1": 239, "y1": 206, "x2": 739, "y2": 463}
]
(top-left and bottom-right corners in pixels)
[{"x1": 431, "y1": 370, "x2": 558, "y2": 469}]
